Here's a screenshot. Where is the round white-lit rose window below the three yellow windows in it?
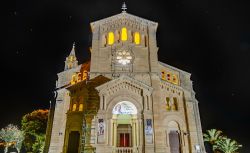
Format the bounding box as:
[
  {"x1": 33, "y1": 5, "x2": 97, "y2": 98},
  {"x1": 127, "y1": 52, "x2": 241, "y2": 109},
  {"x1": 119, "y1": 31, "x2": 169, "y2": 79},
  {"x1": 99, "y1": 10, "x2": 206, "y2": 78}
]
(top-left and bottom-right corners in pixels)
[{"x1": 115, "y1": 49, "x2": 133, "y2": 66}]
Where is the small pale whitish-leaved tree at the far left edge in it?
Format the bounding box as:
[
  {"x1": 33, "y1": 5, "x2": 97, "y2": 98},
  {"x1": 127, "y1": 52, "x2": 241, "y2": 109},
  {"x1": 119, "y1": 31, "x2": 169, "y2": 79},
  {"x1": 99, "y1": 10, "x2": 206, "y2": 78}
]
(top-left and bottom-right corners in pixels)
[{"x1": 0, "y1": 124, "x2": 24, "y2": 152}]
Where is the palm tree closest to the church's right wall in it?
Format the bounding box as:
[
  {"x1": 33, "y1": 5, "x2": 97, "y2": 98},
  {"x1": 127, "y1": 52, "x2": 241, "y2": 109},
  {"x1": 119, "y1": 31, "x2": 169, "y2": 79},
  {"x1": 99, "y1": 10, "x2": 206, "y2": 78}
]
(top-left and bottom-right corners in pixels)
[{"x1": 203, "y1": 129, "x2": 222, "y2": 145}]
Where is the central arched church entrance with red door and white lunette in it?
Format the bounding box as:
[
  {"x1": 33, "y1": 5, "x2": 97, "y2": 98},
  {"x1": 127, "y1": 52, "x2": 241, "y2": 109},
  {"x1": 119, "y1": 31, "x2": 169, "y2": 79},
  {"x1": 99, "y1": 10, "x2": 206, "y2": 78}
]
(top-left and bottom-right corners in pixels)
[{"x1": 112, "y1": 101, "x2": 139, "y2": 152}]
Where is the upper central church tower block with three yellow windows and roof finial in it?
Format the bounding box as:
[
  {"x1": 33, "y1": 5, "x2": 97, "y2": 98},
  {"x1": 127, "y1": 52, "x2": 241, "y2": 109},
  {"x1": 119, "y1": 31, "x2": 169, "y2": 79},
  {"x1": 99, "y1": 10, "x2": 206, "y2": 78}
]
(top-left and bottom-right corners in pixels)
[{"x1": 90, "y1": 3, "x2": 158, "y2": 78}]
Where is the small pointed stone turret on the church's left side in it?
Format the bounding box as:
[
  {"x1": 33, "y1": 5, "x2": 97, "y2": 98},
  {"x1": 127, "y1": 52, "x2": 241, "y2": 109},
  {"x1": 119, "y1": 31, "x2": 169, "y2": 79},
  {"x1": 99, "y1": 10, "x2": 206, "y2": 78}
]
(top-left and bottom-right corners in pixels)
[{"x1": 64, "y1": 43, "x2": 78, "y2": 70}]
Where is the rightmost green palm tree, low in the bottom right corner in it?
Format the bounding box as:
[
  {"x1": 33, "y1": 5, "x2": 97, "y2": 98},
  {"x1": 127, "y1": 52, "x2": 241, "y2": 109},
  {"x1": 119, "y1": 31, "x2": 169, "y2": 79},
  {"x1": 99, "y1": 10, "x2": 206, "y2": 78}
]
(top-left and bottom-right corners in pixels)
[{"x1": 213, "y1": 137, "x2": 242, "y2": 153}]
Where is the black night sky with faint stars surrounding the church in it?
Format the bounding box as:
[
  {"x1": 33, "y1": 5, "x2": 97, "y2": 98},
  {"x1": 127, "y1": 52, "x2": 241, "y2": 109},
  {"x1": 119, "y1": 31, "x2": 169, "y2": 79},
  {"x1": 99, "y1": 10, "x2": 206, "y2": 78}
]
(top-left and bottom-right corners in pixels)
[{"x1": 0, "y1": 0, "x2": 250, "y2": 153}]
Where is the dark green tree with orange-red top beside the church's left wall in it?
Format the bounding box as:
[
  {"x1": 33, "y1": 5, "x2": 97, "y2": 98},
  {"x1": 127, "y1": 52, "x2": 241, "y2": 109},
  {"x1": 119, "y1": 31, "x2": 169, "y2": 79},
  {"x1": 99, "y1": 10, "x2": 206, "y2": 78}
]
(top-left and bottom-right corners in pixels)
[{"x1": 22, "y1": 109, "x2": 48, "y2": 153}]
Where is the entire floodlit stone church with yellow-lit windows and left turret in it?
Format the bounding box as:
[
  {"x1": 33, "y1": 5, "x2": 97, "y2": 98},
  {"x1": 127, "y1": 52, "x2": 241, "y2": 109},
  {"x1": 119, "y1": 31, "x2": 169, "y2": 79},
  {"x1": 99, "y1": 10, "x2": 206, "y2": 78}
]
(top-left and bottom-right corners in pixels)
[{"x1": 45, "y1": 7, "x2": 205, "y2": 153}]
